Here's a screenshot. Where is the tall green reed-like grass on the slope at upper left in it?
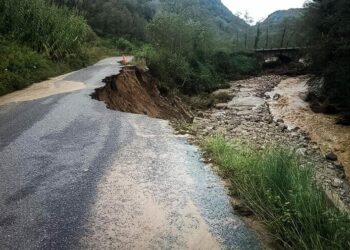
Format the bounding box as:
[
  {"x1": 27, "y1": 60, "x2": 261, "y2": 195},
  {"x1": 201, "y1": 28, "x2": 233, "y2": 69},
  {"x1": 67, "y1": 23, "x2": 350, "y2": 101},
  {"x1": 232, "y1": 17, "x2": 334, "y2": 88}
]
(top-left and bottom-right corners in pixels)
[{"x1": 0, "y1": 0, "x2": 93, "y2": 59}]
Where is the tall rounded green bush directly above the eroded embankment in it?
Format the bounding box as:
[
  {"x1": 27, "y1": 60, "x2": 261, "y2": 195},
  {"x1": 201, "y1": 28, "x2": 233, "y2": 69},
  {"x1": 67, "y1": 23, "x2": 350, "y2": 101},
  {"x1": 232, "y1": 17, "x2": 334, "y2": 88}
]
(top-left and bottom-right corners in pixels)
[{"x1": 137, "y1": 13, "x2": 220, "y2": 94}]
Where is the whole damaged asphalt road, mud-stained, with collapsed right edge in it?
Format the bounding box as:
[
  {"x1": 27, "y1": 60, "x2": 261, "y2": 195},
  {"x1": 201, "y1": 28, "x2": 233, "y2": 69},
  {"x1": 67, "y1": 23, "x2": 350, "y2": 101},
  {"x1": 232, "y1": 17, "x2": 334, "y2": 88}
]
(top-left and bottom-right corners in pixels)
[{"x1": 0, "y1": 58, "x2": 259, "y2": 249}]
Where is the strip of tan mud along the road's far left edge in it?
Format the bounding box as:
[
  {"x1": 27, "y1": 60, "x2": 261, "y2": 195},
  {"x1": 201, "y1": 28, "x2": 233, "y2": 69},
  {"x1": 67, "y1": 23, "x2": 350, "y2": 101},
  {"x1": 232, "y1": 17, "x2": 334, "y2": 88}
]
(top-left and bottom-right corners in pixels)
[{"x1": 0, "y1": 75, "x2": 85, "y2": 106}]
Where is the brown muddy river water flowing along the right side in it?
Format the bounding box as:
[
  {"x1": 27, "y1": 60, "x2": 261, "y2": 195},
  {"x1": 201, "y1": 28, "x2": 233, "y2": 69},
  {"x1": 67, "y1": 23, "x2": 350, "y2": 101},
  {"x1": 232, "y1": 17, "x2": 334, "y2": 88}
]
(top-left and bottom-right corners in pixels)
[{"x1": 268, "y1": 77, "x2": 350, "y2": 177}]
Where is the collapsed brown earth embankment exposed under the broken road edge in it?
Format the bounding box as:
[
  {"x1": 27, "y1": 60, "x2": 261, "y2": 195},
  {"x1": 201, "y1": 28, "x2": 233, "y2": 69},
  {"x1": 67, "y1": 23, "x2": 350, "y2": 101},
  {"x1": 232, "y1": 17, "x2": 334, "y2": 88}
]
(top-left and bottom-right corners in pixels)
[{"x1": 92, "y1": 66, "x2": 192, "y2": 121}]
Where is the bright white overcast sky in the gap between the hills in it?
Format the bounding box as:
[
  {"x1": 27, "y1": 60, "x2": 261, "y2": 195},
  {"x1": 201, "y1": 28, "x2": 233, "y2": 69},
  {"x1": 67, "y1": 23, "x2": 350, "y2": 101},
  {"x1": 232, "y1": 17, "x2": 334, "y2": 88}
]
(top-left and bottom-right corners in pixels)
[{"x1": 221, "y1": 0, "x2": 305, "y2": 22}]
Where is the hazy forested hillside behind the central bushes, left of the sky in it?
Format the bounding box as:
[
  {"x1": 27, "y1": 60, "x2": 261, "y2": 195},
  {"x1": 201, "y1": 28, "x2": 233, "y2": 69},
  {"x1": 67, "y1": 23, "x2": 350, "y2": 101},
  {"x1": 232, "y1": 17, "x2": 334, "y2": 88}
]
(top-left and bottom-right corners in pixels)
[{"x1": 79, "y1": 0, "x2": 249, "y2": 39}]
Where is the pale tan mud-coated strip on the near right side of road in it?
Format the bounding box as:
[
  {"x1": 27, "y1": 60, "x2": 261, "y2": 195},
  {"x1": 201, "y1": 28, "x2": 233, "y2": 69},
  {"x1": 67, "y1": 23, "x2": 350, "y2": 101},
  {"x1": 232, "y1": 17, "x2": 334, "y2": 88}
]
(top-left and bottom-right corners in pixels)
[{"x1": 80, "y1": 114, "x2": 260, "y2": 250}]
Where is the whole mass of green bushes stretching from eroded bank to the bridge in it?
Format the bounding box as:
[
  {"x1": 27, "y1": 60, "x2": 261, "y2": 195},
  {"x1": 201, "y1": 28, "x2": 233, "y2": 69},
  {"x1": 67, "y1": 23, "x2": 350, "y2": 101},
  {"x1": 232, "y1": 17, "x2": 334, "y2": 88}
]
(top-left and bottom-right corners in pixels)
[{"x1": 136, "y1": 11, "x2": 259, "y2": 95}]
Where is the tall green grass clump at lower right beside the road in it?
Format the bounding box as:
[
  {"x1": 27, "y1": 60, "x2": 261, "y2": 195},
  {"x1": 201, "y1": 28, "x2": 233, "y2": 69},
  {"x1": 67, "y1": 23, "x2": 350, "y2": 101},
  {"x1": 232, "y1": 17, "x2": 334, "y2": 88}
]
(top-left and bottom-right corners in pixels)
[{"x1": 204, "y1": 136, "x2": 350, "y2": 249}]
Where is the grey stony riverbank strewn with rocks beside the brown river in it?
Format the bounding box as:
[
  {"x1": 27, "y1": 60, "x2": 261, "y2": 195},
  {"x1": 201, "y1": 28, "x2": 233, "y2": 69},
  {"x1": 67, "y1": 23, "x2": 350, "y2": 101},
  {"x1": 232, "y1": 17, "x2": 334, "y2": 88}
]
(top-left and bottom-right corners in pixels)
[{"x1": 180, "y1": 75, "x2": 350, "y2": 209}]
